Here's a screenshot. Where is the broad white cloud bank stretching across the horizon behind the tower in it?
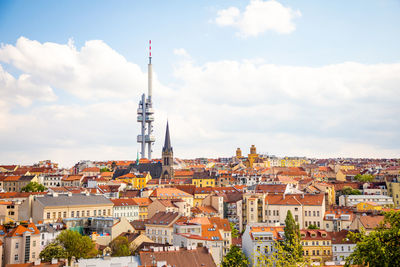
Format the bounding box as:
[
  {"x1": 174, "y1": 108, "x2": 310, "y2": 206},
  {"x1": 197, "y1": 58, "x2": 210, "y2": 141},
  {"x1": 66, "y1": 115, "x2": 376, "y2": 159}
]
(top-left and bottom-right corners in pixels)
[{"x1": 0, "y1": 38, "x2": 400, "y2": 166}]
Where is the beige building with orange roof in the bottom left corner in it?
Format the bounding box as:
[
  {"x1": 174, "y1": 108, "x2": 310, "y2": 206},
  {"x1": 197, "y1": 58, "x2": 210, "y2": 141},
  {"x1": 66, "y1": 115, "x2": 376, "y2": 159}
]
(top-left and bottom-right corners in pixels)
[{"x1": 3, "y1": 223, "x2": 40, "y2": 264}]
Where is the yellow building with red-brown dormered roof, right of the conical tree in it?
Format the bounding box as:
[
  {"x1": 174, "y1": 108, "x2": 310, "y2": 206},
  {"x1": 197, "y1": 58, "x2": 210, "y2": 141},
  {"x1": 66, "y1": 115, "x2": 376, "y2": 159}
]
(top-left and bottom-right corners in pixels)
[{"x1": 300, "y1": 230, "x2": 332, "y2": 263}]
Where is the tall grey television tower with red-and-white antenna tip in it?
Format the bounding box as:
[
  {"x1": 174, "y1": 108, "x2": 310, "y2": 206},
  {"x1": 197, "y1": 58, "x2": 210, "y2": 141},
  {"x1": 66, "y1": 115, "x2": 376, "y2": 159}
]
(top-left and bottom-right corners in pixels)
[{"x1": 137, "y1": 40, "x2": 156, "y2": 160}]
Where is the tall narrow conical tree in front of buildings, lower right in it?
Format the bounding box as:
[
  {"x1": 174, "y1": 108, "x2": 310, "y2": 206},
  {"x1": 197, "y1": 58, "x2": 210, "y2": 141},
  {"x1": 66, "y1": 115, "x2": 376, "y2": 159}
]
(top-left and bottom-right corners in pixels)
[{"x1": 283, "y1": 210, "x2": 303, "y2": 261}]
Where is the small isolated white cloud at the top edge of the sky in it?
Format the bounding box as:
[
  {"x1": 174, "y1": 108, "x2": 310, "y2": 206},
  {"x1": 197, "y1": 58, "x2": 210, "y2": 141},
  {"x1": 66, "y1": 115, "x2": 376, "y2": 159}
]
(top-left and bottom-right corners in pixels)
[{"x1": 215, "y1": 0, "x2": 301, "y2": 37}]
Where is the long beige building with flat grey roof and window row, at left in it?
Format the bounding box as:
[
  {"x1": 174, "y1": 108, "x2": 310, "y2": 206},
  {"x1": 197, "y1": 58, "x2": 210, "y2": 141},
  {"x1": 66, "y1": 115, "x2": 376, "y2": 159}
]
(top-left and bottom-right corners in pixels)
[{"x1": 30, "y1": 193, "x2": 113, "y2": 223}]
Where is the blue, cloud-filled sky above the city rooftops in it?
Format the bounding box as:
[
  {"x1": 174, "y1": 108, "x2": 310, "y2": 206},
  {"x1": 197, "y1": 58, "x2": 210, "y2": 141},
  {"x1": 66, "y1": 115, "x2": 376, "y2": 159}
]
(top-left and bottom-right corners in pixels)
[{"x1": 0, "y1": 0, "x2": 400, "y2": 167}]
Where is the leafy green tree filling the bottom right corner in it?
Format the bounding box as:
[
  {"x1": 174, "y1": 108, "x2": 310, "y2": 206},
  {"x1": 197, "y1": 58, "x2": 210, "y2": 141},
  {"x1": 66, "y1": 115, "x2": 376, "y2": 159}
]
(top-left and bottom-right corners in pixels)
[{"x1": 346, "y1": 211, "x2": 400, "y2": 267}]
